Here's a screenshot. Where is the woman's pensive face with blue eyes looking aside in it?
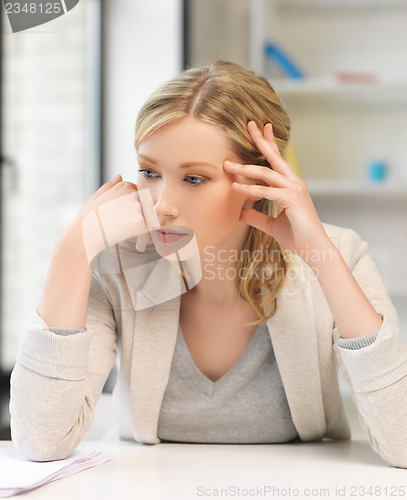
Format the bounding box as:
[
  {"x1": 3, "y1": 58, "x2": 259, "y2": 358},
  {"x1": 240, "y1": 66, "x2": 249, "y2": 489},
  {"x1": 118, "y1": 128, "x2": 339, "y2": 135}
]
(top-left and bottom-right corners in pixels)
[{"x1": 137, "y1": 117, "x2": 255, "y2": 252}]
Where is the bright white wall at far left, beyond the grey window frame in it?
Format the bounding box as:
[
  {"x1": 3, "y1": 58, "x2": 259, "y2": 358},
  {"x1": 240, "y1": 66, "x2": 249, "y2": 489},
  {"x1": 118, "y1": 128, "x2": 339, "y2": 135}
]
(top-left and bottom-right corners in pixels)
[{"x1": 1, "y1": 0, "x2": 90, "y2": 369}]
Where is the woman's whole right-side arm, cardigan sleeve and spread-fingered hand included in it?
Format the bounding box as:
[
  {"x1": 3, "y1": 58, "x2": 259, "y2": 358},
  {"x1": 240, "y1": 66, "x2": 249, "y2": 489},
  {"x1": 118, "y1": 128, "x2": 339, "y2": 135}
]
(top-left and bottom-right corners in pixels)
[{"x1": 224, "y1": 122, "x2": 407, "y2": 468}]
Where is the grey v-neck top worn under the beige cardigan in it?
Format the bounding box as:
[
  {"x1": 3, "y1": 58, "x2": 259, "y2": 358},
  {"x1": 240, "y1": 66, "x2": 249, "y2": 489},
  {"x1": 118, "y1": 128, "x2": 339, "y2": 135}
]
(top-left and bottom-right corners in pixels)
[{"x1": 157, "y1": 323, "x2": 300, "y2": 443}]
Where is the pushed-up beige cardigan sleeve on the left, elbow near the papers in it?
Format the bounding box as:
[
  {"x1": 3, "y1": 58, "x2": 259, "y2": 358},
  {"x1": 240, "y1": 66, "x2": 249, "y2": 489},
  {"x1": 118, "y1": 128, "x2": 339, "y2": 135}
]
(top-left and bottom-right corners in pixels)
[{"x1": 10, "y1": 273, "x2": 116, "y2": 461}]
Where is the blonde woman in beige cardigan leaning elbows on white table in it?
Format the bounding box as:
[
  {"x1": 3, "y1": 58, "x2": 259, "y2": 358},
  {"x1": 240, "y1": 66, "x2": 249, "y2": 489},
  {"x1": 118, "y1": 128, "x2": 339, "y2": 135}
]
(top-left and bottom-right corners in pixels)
[{"x1": 11, "y1": 61, "x2": 407, "y2": 467}]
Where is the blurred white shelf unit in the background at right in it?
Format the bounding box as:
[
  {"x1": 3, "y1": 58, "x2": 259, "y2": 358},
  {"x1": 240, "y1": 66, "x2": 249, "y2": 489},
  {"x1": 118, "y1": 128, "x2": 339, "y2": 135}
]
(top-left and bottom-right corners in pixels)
[{"x1": 250, "y1": 0, "x2": 407, "y2": 337}]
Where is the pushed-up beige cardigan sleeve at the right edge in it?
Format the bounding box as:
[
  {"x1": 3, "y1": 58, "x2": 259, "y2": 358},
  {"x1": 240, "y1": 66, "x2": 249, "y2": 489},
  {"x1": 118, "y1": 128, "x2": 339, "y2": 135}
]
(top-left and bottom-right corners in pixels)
[{"x1": 333, "y1": 230, "x2": 407, "y2": 468}]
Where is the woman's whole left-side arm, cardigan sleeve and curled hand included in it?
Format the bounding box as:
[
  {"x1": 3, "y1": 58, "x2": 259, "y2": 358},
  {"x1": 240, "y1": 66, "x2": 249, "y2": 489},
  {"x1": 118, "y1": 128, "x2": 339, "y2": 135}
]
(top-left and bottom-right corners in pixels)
[{"x1": 10, "y1": 176, "x2": 151, "y2": 461}]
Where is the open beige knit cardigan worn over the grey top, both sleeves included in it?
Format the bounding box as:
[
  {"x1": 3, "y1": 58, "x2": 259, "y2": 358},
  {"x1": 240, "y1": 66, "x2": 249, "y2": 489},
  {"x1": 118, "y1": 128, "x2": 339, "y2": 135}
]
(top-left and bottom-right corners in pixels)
[{"x1": 10, "y1": 224, "x2": 407, "y2": 468}]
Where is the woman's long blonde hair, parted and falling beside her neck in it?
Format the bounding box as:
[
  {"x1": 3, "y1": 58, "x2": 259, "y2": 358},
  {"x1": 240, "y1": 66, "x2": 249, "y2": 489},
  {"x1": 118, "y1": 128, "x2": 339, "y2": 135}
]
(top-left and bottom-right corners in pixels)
[{"x1": 135, "y1": 60, "x2": 290, "y2": 325}]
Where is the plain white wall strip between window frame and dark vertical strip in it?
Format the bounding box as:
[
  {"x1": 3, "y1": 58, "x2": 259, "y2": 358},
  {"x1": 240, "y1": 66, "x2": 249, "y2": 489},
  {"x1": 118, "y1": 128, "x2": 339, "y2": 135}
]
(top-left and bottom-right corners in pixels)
[{"x1": 104, "y1": 0, "x2": 182, "y2": 182}]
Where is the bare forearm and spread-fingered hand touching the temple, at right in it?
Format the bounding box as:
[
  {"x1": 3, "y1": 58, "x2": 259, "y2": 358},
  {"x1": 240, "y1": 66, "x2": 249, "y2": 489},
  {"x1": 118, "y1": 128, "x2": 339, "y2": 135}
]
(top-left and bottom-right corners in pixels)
[{"x1": 224, "y1": 122, "x2": 388, "y2": 338}]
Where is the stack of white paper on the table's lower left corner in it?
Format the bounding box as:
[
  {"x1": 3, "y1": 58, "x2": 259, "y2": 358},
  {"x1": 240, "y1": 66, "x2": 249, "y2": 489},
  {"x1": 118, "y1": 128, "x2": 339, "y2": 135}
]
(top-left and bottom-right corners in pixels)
[{"x1": 0, "y1": 448, "x2": 110, "y2": 498}]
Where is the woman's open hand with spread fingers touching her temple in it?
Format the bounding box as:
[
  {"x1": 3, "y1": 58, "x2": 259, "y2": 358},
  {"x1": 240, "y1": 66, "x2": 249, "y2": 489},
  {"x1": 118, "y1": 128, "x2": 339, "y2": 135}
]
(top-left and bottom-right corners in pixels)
[{"x1": 224, "y1": 121, "x2": 331, "y2": 260}]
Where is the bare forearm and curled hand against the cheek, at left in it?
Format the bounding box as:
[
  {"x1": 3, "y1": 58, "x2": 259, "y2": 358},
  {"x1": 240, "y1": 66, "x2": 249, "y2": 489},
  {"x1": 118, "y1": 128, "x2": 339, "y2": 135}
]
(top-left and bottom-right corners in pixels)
[{"x1": 38, "y1": 175, "x2": 147, "y2": 329}]
